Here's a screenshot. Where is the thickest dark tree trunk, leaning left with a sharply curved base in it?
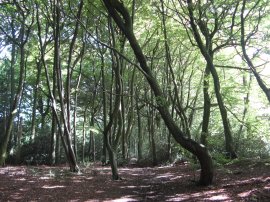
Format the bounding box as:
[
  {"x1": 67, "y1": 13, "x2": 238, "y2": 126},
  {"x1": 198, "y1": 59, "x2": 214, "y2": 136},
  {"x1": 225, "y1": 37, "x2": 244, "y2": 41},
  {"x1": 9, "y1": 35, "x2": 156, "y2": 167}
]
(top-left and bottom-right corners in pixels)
[{"x1": 103, "y1": 0, "x2": 214, "y2": 185}]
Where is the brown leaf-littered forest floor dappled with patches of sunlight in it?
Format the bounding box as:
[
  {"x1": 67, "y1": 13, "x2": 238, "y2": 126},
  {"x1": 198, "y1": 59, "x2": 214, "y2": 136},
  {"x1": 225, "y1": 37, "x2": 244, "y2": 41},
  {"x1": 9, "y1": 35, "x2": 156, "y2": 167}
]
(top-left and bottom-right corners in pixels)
[{"x1": 0, "y1": 160, "x2": 270, "y2": 202}]
